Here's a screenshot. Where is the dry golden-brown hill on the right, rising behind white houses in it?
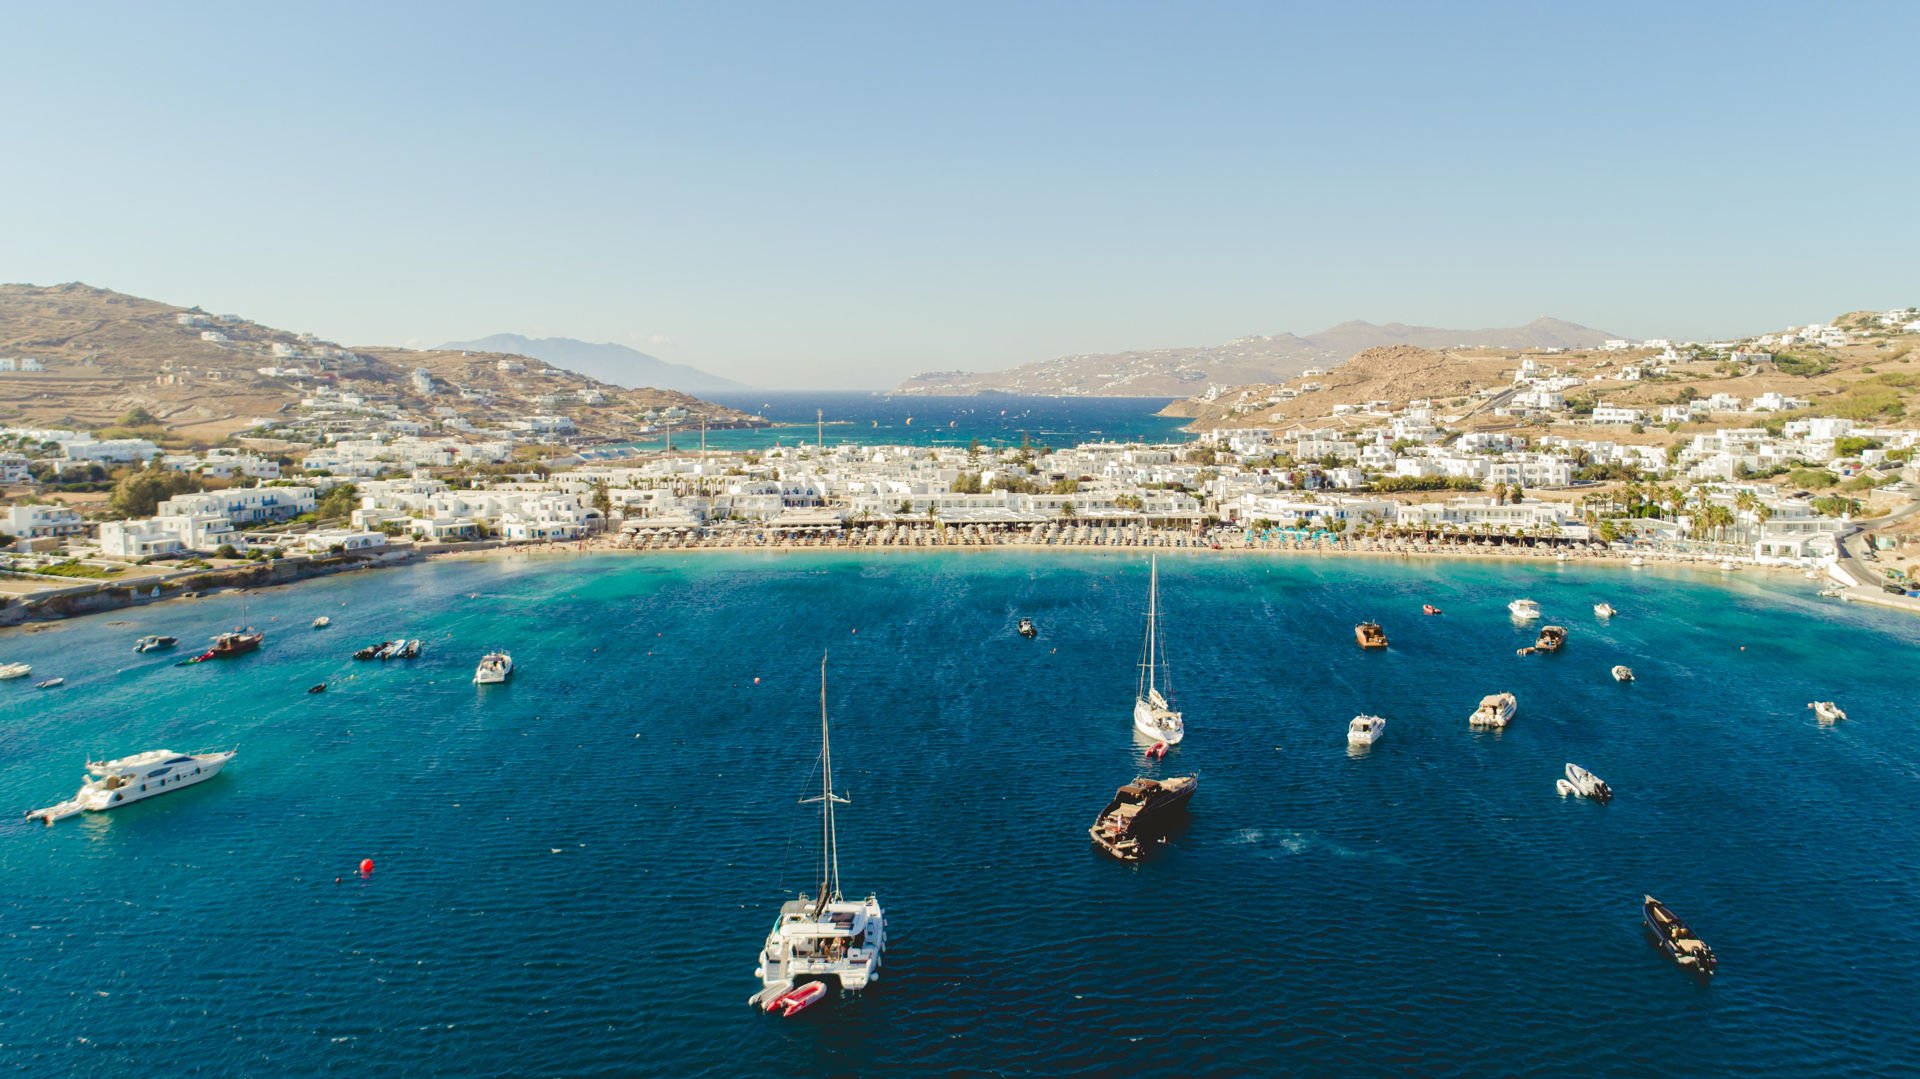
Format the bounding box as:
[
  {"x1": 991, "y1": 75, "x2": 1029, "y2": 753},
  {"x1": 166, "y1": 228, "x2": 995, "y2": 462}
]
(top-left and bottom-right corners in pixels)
[{"x1": 1164, "y1": 328, "x2": 1920, "y2": 442}]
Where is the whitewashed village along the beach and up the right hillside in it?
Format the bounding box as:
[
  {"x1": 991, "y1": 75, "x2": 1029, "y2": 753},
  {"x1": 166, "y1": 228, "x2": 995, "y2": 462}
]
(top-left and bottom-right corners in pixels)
[{"x1": 0, "y1": 297, "x2": 1920, "y2": 622}]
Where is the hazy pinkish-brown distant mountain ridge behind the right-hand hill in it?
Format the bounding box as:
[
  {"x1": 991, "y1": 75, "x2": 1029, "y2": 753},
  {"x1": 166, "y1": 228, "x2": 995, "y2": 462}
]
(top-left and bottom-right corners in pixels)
[{"x1": 895, "y1": 319, "x2": 1617, "y2": 397}]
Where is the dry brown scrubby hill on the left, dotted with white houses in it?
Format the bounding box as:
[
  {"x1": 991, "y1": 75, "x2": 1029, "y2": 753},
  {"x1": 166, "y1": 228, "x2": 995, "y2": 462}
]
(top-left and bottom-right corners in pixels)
[{"x1": 0, "y1": 284, "x2": 745, "y2": 442}]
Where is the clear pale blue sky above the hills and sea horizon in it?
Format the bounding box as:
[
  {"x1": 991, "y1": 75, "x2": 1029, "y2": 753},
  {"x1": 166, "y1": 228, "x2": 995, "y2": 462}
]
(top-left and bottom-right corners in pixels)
[{"x1": 0, "y1": 0, "x2": 1920, "y2": 388}]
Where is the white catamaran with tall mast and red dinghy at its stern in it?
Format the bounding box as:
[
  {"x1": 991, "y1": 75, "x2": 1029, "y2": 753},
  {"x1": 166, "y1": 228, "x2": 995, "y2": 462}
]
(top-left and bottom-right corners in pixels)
[{"x1": 747, "y1": 653, "x2": 887, "y2": 1018}]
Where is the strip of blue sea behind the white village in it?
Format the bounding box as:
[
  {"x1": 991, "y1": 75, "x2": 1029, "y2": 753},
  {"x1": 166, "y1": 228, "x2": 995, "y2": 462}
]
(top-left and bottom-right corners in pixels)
[{"x1": 610, "y1": 390, "x2": 1192, "y2": 449}]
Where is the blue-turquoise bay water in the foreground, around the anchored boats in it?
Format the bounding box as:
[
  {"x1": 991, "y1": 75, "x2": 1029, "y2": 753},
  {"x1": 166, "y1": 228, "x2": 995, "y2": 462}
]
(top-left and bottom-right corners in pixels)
[{"x1": 0, "y1": 551, "x2": 1920, "y2": 1075}]
